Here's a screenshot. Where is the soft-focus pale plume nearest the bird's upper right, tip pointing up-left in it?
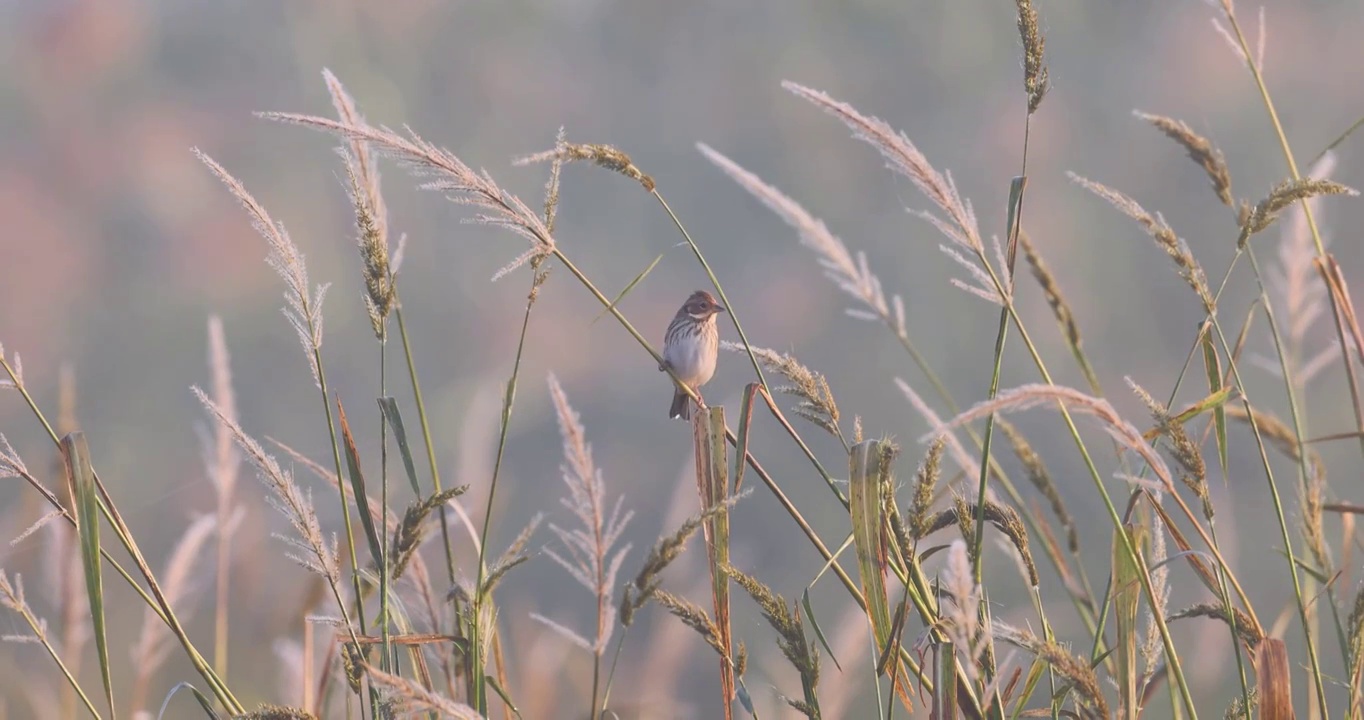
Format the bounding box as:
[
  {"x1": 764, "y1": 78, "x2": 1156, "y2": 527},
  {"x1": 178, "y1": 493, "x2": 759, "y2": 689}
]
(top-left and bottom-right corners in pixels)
[{"x1": 698, "y1": 145, "x2": 906, "y2": 335}]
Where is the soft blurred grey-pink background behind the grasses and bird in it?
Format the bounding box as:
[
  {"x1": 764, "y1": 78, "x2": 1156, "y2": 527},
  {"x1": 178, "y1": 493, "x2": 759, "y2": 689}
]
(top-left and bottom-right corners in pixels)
[{"x1": 0, "y1": 0, "x2": 1364, "y2": 717}]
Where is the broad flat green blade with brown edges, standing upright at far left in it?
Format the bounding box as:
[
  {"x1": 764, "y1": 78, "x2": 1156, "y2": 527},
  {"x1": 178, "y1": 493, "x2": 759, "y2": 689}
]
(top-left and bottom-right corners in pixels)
[{"x1": 61, "y1": 432, "x2": 119, "y2": 719}]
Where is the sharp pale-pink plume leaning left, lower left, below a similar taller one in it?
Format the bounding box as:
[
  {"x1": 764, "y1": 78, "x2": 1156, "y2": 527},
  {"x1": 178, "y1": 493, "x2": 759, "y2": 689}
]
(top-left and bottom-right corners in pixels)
[{"x1": 194, "y1": 387, "x2": 345, "y2": 594}]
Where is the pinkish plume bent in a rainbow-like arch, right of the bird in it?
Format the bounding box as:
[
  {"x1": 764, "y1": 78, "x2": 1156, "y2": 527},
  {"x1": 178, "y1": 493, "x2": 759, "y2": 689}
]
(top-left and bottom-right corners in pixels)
[{"x1": 921, "y1": 383, "x2": 1174, "y2": 492}]
